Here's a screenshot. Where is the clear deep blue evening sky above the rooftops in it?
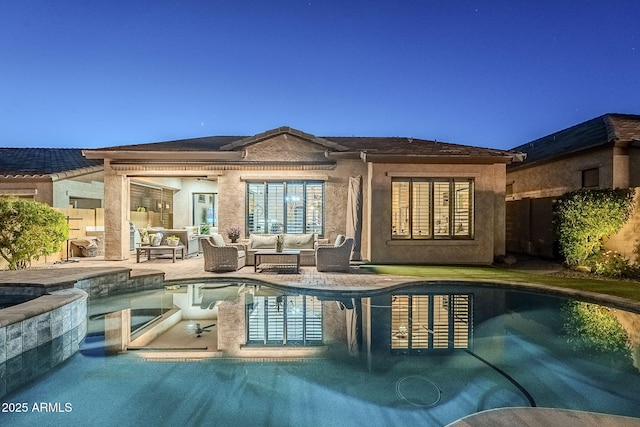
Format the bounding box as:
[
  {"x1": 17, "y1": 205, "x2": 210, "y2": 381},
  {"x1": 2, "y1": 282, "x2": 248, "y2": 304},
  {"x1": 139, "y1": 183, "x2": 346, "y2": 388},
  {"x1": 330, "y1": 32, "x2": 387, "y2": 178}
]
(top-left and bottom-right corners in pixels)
[{"x1": 0, "y1": 0, "x2": 640, "y2": 148}]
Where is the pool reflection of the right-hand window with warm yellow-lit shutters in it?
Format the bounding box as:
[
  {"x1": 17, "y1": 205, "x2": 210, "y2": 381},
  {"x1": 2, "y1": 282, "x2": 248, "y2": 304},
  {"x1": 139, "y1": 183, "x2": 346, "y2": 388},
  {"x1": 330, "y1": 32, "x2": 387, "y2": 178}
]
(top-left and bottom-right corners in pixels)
[{"x1": 391, "y1": 294, "x2": 473, "y2": 353}]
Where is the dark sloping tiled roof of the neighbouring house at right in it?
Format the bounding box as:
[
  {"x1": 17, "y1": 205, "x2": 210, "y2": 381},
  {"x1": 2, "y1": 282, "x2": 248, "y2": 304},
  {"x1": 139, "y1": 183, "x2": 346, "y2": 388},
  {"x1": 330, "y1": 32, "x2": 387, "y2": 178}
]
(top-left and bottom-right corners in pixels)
[{"x1": 504, "y1": 114, "x2": 640, "y2": 168}]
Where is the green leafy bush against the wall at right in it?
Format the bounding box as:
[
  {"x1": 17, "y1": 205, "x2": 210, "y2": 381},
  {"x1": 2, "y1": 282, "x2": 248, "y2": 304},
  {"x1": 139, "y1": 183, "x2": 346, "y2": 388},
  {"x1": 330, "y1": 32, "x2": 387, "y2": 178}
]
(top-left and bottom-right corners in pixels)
[{"x1": 553, "y1": 189, "x2": 633, "y2": 266}]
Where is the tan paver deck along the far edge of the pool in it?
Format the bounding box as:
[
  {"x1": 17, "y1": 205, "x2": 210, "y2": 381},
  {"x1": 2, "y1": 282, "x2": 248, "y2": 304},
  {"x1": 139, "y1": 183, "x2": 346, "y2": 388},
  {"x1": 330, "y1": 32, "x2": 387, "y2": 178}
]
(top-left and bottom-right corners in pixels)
[{"x1": 0, "y1": 254, "x2": 640, "y2": 313}]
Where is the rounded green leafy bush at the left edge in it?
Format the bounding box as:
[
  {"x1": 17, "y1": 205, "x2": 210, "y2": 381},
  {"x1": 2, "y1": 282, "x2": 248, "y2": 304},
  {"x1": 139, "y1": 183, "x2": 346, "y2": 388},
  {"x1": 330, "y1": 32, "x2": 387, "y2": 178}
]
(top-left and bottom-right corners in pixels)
[{"x1": 0, "y1": 197, "x2": 69, "y2": 270}]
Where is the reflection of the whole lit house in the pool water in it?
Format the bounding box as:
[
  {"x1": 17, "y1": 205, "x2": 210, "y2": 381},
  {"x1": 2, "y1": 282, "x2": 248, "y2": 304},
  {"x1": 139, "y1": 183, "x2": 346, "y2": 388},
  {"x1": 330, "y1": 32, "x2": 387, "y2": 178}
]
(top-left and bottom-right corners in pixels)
[{"x1": 97, "y1": 283, "x2": 484, "y2": 358}]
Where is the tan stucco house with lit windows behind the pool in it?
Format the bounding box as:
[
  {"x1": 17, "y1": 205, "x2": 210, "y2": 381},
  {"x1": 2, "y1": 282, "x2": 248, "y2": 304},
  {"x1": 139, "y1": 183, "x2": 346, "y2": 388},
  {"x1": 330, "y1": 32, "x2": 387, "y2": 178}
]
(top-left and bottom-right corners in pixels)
[{"x1": 83, "y1": 127, "x2": 521, "y2": 264}]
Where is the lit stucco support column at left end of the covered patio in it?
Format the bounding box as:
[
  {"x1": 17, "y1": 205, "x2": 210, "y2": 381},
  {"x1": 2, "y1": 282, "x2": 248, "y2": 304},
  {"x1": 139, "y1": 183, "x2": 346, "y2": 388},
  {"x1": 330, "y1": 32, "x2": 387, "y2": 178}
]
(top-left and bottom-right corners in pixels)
[{"x1": 104, "y1": 166, "x2": 131, "y2": 261}]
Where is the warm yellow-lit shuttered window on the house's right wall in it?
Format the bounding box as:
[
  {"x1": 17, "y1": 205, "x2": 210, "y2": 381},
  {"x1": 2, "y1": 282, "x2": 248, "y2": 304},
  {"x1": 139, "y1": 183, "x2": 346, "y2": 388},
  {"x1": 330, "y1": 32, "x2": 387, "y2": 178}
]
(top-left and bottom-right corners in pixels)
[{"x1": 391, "y1": 178, "x2": 473, "y2": 239}]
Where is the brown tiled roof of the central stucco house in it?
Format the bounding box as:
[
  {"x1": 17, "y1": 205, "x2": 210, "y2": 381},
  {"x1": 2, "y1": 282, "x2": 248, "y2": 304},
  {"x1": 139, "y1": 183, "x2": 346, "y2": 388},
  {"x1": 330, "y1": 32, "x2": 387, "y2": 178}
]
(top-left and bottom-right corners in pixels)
[{"x1": 85, "y1": 126, "x2": 521, "y2": 161}]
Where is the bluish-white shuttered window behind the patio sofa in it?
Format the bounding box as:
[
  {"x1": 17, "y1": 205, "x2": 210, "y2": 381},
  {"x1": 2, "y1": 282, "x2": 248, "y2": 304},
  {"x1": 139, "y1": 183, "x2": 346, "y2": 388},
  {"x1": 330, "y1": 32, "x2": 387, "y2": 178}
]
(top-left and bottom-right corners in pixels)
[{"x1": 246, "y1": 181, "x2": 324, "y2": 236}]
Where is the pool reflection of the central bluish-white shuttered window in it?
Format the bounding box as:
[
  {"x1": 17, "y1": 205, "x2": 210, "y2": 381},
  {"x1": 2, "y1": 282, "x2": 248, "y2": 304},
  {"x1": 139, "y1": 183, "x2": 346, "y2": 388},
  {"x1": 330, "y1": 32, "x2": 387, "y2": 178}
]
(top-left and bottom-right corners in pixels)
[{"x1": 246, "y1": 295, "x2": 322, "y2": 346}]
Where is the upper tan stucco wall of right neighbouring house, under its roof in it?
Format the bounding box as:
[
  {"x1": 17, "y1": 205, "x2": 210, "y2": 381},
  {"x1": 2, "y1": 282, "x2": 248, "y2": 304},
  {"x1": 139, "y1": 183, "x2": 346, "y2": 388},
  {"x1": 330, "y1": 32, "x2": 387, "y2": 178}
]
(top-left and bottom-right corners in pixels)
[{"x1": 507, "y1": 149, "x2": 613, "y2": 200}]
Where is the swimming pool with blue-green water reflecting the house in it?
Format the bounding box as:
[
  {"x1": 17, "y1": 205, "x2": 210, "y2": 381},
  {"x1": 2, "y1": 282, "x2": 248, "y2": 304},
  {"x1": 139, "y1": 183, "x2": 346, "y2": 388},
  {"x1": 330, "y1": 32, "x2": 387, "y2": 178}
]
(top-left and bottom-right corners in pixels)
[{"x1": 2, "y1": 282, "x2": 640, "y2": 426}]
